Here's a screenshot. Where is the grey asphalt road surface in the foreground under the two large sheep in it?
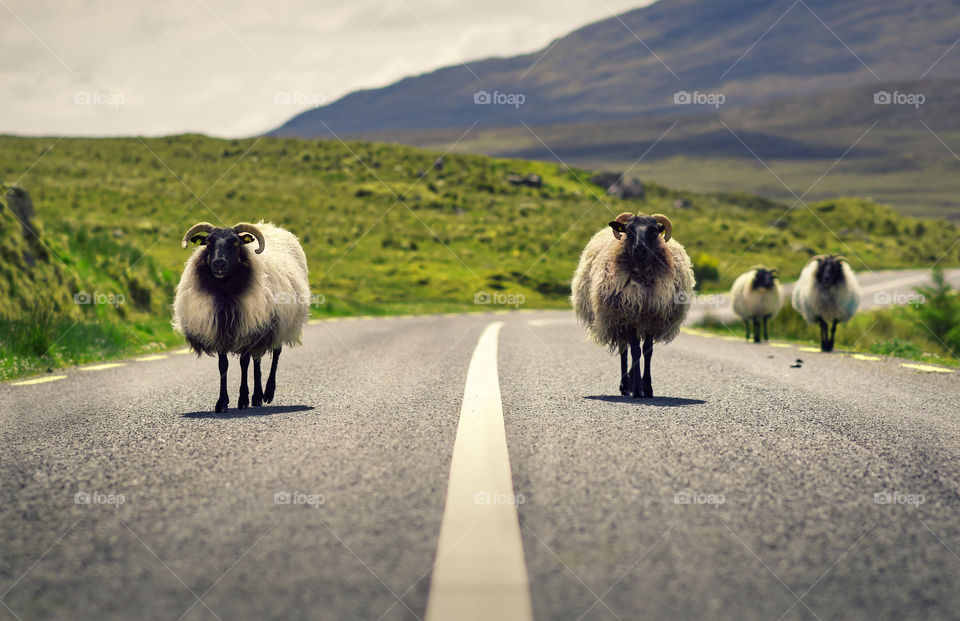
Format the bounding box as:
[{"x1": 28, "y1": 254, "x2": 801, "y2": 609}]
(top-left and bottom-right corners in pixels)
[{"x1": 0, "y1": 268, "x2": 960, "y2": 621}]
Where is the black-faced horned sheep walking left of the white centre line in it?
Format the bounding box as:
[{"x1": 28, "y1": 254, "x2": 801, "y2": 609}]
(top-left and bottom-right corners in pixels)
[{"x1": 173, "y1": 222, "x2": 310, "y2": 413}]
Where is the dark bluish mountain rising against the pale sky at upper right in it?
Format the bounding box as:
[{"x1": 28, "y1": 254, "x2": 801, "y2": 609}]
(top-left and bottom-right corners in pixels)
[{"x1": 271, "y1": 0, "x2": 960, "y2": 137}]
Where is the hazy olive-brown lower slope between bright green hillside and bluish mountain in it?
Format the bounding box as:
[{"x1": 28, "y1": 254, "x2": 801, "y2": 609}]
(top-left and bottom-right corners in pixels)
[{"x1": 356, "y1": 79, "x2": 960, "y2": 221}]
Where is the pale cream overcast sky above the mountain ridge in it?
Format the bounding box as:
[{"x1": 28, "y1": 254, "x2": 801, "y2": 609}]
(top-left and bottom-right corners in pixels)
[{"x1": 0, "y1": 0, "x2": 651, "y2": 137}]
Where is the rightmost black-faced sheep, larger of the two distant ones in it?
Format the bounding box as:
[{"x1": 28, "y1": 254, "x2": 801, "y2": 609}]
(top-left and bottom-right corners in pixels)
[{"x1": 792, "y1": 254, "x2": 860, "y2": 352}]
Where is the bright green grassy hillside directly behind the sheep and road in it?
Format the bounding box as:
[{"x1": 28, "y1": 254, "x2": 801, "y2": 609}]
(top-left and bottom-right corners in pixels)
[{"x1": 0, "y1": 135, "x2": 960, "y2": 376}]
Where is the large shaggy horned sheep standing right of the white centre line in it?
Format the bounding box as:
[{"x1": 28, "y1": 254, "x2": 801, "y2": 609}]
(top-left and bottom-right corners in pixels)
[{"x1": 570, "y1": 212, "x2": 695, "y2": 399}]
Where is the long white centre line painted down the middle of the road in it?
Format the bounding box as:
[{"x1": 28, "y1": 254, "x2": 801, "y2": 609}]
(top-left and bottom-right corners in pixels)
[{"x1": 426, "y1": 321, "x2": 533, "y2": 621}]
